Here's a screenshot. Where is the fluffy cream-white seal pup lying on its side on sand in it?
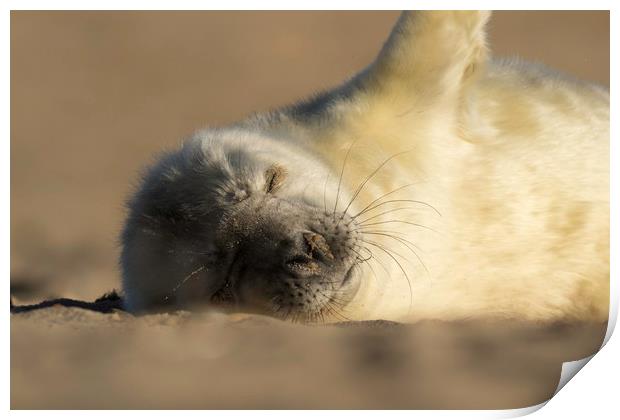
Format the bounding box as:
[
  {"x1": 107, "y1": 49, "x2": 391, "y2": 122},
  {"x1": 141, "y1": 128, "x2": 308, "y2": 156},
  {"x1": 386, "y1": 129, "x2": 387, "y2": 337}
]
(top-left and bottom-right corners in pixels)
[{"x1": 120, "y1": 11, "x2": 609, "y2": 322}]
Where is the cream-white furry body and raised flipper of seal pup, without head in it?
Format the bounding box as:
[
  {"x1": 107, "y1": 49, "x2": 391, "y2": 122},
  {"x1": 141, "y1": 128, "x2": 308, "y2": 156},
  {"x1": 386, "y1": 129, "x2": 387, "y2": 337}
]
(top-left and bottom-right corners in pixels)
[{"x1": 248, "y1": 12, "x2": 609, "y2": 320}]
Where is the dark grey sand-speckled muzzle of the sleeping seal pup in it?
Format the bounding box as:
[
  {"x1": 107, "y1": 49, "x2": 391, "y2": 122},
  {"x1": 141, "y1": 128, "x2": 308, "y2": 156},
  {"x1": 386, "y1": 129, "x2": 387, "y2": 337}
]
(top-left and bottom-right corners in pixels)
[{"x1": 209, "y1": 194, "x2": 359, "y2": 320}]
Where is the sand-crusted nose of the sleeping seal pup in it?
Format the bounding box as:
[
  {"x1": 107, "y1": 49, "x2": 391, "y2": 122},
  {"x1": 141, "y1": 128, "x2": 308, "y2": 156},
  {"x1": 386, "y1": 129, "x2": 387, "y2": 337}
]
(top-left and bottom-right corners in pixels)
[{"x1": 284, "y1": 232, "x2": 334, "y2": 277}]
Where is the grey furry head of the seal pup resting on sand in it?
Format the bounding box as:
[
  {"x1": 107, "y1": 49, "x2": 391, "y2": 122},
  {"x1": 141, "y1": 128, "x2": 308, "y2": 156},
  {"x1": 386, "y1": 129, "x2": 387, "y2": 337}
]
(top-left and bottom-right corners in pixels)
[{"x1": 121, "y1": 129, "x2": 361, "y2": 321}]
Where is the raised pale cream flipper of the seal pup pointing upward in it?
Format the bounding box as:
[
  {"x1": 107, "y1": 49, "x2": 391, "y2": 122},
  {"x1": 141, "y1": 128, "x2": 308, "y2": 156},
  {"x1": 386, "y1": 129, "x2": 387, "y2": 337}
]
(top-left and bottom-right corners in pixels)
[{"x1": 364, "y1": 11, "x2": 490, "y2": 106}]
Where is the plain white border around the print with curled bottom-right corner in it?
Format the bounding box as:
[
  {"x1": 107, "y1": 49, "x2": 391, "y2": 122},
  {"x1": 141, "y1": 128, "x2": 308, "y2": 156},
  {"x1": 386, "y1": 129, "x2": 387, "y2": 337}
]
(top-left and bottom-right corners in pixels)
[{"x1": 0, "y1": 0, "x2": 620, "y2": 420}]
